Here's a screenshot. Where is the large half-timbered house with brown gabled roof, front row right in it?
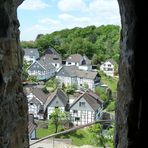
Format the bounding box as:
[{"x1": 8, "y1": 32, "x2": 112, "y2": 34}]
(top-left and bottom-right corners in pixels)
[{"x1": 70, "y1": 90, "x2": 103, "y2": 126}]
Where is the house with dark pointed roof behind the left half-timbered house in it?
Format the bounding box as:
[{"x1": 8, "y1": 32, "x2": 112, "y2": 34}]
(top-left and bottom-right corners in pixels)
[{"x1": 44, "y1": 47, "x2": 62, "y2": 71}]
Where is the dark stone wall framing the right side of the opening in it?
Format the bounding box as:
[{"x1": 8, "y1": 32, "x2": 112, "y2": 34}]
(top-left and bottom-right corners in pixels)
[{"x1": 115, "y1": 0, "x2": 148, "y2": 148}]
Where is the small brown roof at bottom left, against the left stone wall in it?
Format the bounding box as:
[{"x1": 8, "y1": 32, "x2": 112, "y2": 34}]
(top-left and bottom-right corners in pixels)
[{"x1": 28, "y1": 114, "x2": 37, "y2": 135}]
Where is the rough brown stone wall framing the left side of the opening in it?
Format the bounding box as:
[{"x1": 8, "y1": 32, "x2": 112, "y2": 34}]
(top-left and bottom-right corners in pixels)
[{"x1": 0, "y1": 0, "x2": 28, "y2": 148}]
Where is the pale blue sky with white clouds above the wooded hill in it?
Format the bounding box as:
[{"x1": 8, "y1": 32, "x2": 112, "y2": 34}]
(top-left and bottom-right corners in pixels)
[{"x1": 17, "y1": 0, "x2": 120, "y2": 41}]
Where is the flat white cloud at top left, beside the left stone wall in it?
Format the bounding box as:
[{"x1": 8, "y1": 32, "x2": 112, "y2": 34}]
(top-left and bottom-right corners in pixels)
[{"x1": 19, "y1": 0, "x2": 50, "y2": 10}]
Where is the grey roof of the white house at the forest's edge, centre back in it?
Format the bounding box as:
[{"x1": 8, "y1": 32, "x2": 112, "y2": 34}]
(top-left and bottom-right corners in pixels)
[{"x1": 66, "y1": 54, "x2": 91, "y2": 65}]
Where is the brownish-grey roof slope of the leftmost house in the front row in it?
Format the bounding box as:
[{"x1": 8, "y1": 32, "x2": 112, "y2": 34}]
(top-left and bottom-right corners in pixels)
[{"x1": 32, "y1": 88, "x2": 50, "y2": 104}]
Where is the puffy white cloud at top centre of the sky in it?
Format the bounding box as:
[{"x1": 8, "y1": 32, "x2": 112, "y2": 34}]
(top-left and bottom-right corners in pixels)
[{"x1": 58, "y1": 0, "x2": 86, "y2": 12}]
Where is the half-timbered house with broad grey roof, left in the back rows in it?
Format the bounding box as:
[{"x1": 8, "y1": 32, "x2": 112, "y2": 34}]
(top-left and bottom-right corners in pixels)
[{"x1": 27, "y1": 55, "x2": 56, "y2": 80}]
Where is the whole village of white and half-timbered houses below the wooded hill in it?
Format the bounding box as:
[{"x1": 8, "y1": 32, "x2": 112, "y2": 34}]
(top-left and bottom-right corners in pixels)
[{"x1": 23, "y1": 47, "x2": 117, "y2": 140}]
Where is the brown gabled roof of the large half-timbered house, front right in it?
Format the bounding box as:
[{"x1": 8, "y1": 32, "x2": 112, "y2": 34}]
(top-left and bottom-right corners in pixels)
[{"x1": 70, "y1": 92, "x2": 103, "y2": 111}]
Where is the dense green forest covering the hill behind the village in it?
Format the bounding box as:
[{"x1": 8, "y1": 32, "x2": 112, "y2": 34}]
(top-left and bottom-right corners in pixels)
[{"x1": 21, "y1": 25, "x2": 120, "y2": 65}]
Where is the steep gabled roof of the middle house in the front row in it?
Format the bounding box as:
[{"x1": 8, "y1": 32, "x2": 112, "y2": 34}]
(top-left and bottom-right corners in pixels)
[{"x1": 44, "y1": 88, "x2": 68, "y2": 110}]
